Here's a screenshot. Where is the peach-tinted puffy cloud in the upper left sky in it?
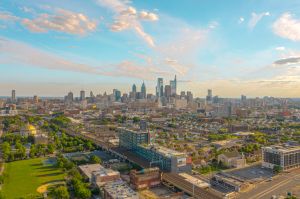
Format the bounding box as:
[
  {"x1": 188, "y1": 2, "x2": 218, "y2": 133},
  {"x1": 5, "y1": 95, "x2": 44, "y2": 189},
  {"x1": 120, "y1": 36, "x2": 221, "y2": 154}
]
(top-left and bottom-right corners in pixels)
[{"x1": 21, "y1": 9, "x2": 97, "y2": 35}]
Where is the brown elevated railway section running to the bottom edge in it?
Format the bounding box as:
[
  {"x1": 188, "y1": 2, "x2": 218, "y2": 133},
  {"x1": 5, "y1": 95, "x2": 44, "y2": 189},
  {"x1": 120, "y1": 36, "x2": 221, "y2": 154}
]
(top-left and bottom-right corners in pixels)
[{"x1": 162, "y1": 173, "x2": 223, "y2": 199}]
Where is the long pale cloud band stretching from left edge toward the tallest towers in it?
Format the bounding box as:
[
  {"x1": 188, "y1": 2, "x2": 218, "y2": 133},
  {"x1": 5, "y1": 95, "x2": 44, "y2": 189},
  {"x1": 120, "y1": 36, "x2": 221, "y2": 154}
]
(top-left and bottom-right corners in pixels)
[{"x1": 0, "y1": 37, "x2": 169, "y2": 79}]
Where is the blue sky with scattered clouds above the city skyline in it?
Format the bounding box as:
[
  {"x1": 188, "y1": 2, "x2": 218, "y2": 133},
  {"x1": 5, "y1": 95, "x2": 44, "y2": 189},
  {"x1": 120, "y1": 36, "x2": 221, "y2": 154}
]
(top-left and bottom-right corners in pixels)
[{"x1": 0, "y1": 0, "x2": 300, "y2": 97}]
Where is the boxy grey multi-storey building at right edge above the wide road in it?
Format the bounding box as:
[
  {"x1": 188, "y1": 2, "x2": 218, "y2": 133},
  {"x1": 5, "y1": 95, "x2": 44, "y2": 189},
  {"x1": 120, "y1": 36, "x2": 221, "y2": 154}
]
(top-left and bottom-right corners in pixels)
[{"x1": 262, "y1": 145, "x2": 300, "y2": 171}]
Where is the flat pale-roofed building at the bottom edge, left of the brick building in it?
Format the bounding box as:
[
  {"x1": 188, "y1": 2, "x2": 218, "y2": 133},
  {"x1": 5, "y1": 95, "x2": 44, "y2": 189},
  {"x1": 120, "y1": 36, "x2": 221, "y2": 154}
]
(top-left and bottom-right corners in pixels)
[{"x1": 103, "y1": 180, "x2": 139, "y2": 199}]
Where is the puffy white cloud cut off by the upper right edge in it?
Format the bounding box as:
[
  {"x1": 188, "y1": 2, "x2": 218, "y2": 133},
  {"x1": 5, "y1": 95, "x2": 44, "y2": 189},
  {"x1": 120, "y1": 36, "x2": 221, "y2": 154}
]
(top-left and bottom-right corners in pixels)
[{"x1": 273, "y1": 13, "x2": 300, "y2": 41}]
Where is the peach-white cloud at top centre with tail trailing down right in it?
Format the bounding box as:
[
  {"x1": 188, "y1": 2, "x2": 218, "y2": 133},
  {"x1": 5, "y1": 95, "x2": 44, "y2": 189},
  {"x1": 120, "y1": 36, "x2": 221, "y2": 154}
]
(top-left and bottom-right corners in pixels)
[{"x1": 97, "y1": 0, "x2": 158, "y2": 47}]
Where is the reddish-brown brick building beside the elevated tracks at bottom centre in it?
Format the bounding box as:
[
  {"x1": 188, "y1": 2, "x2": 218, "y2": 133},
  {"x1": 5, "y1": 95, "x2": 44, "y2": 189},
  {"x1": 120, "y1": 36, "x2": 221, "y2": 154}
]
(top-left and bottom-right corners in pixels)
[{"x1": 130, "y1": 167, "x2": 161, "y2": 190}]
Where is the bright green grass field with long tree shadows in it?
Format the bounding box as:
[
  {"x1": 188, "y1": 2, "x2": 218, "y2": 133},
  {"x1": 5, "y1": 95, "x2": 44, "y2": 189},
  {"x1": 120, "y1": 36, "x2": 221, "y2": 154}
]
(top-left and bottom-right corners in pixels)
[{"x1": 2, "y1": 158, "x2": 65, "y2": 199}]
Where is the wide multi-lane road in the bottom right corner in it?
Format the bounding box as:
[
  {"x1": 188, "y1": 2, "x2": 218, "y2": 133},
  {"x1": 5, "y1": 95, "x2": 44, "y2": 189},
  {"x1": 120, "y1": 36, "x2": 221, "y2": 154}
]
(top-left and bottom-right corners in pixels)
[{"x1": 237, "y1": 169, "x2": 300, "y2": 199}]
